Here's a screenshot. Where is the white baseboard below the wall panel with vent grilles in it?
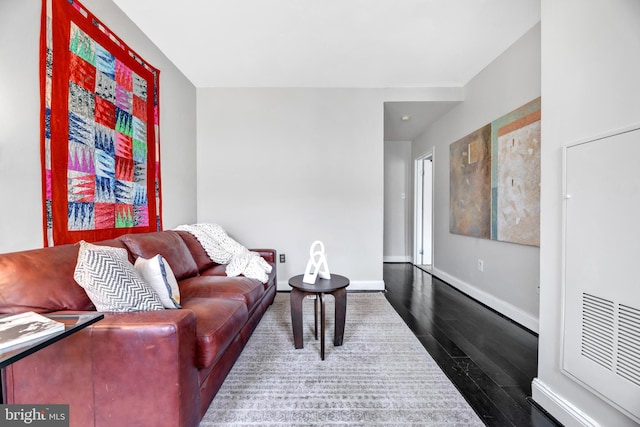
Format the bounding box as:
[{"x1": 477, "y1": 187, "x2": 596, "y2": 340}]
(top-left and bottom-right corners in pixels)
[{"x1": 531, "y1": 378, "x2": 600, "y2": 427}]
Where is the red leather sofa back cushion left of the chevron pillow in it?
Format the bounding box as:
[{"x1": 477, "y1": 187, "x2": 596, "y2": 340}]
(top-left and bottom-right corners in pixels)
[{"x1": 0, "y1": 245, "x2": 95, "y2": 313}]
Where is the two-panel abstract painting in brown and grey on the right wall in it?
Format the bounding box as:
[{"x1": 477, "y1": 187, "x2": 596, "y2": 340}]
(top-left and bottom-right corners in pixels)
[{"x1": 449, "y1": 98, "x2": 541, "y2": 246}]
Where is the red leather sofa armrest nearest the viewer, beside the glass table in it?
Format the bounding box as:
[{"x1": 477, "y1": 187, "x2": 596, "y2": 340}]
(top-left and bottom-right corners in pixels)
[{"x1": 5, "y1": 310, "x2": 200, "y2": 427}]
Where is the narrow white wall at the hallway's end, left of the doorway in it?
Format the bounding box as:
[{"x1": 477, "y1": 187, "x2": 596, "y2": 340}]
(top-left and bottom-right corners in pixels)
[{"x1": 383, "y1": 141, "x2": 413, "y2": 262}]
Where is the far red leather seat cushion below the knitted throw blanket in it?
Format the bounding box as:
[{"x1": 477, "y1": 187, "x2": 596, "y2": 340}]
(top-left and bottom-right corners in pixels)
[{"x1": 178, "y1": 276, "x2": 264, "y2": 311}]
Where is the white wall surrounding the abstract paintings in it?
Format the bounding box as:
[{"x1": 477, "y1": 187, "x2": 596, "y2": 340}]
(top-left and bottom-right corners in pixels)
[{"x1": 413, "y1": 24, "x2": 545, "y2": 331}]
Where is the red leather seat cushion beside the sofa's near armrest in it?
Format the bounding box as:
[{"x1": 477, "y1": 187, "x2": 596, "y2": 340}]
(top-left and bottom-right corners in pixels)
[{"x1": 182, "y1": 296, "x2": 249, "y2": 369}]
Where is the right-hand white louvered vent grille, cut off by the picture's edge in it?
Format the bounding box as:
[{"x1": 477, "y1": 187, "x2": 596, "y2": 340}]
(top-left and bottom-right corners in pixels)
[{"x1": 616, "y1": 304, "x2": 640, "y2": 386}]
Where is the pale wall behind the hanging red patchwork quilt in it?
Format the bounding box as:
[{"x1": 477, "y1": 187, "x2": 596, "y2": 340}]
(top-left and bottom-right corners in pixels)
[{"x1": 0, "y1": 0, "x2": 196, "y2": 252}]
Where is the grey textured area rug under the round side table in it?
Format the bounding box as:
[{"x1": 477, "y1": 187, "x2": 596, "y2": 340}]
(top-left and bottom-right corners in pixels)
[{"x1": 200, "y1": 293, "x2": 484, "y2": 427}]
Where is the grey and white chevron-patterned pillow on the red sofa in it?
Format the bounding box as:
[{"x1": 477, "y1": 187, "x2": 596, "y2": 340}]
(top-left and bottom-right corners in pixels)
[{"x1": 73, "y1": 241, "x2": 164, "y2": 312}]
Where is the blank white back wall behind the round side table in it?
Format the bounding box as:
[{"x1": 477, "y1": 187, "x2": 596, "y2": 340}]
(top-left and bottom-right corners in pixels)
[{"x1": 198, "y1": 88, "x2": 383, "y2": 289}]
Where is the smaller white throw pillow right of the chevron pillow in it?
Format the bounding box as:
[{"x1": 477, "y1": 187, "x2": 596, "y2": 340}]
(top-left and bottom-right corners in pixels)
[{"x1": 134, "y1": 254, "x2": 181, "y2": 308}]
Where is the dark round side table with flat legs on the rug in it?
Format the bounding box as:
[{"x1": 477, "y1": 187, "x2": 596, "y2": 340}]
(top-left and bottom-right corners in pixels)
[{"x1": 289, "y1": 274, "x2": 349, "y2": 360}]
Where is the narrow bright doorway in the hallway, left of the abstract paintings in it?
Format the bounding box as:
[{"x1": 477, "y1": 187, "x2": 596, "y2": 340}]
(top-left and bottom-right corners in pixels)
[{"x1": 413, "y1": 149, "x2": 433, "y2": 273}]
